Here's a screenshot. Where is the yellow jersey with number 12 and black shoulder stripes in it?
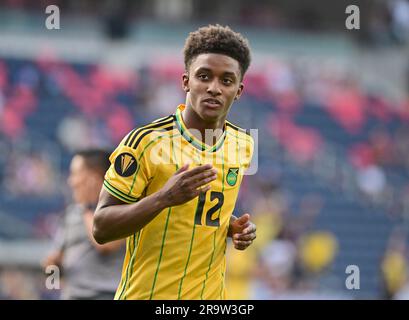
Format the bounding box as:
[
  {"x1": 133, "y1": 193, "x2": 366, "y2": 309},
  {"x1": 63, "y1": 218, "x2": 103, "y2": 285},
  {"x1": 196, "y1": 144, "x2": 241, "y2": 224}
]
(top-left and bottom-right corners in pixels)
[{"x1": 104, "y1": 105, "x2": 254, "y2": 300}]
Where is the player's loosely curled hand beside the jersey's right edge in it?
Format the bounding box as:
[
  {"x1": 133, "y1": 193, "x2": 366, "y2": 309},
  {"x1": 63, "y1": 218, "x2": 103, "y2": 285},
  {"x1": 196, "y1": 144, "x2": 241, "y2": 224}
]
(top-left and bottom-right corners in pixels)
[{"x1": 229, "y1": 213, "x2": 257, "y2": 250}]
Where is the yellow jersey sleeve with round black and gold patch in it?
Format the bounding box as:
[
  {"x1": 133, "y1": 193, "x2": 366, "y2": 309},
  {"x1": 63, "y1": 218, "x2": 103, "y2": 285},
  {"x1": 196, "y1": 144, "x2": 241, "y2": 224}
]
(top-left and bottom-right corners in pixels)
[{"x1": 104, "y1": 132, "x2": 150, "y2": 203}]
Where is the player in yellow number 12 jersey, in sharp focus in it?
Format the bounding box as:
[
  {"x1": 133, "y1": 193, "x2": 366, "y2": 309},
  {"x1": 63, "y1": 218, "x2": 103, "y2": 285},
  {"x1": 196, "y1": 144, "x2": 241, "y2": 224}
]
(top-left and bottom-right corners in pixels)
[{"x1": 93, "y1": 25, "x2": 256, "y2": 299}]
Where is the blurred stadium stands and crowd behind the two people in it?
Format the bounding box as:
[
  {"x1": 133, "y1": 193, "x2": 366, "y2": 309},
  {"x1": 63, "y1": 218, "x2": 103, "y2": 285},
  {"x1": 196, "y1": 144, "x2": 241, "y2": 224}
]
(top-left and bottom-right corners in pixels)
[{"x1": 0, "y1": 0, "x2": 409, "y2": 299}]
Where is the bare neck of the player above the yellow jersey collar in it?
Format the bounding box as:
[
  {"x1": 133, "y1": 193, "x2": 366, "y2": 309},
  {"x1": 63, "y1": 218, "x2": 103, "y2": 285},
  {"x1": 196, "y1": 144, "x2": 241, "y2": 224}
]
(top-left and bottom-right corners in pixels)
[{"x1": 182, "y1": 106, "x2": 226, "y2": 144}]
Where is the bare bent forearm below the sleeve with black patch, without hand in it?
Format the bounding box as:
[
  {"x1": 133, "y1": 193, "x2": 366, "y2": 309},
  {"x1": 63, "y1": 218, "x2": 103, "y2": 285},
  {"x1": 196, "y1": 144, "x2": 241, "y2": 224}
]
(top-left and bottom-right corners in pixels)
[{"x1": 93, "y1": 192, "x2": 168, "y2": 244}]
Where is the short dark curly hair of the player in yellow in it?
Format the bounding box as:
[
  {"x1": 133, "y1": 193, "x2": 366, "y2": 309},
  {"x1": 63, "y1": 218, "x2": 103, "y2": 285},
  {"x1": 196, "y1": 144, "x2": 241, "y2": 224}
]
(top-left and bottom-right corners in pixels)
[{"x1": 183, "y1": 24, "x2": 251, "y2": 79}]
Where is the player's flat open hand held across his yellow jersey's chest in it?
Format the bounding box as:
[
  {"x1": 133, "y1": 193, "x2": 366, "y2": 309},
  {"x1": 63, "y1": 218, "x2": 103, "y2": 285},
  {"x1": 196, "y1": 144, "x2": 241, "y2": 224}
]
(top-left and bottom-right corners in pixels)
[{"x1": 160, "y1": 164, "x2": 217, "y2": 207}]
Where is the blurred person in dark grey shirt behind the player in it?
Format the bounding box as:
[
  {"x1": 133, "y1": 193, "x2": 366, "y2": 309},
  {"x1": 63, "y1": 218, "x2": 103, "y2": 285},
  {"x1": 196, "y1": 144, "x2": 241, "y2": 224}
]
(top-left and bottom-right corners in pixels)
[{"x1": 43, "y1": 149, "x2": 125, "y2": 300}]
